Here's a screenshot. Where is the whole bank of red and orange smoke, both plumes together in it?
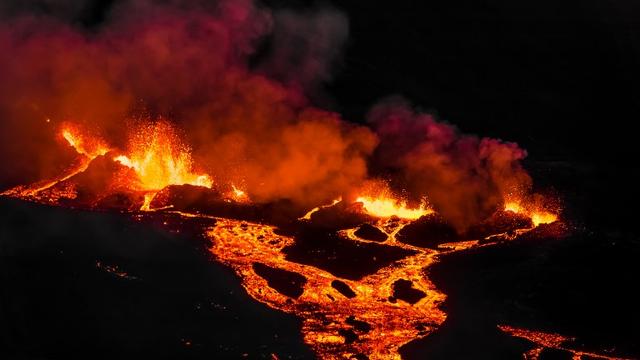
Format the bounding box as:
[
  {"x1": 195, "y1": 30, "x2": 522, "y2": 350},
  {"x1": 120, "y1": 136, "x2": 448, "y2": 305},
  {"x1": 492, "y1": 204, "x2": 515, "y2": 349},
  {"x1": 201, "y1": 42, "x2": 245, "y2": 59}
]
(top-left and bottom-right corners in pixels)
[{"x1": 0, "y1": 0, "x2": 530, "y2": 228}]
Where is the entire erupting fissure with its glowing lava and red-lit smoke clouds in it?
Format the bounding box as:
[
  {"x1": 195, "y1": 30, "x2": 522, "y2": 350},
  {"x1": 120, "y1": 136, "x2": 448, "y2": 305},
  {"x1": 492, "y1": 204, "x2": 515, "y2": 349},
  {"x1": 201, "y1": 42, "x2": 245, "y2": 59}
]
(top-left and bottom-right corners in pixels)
[{"x1": 0, "y1": 0, "x2": 624, "y2": 359}]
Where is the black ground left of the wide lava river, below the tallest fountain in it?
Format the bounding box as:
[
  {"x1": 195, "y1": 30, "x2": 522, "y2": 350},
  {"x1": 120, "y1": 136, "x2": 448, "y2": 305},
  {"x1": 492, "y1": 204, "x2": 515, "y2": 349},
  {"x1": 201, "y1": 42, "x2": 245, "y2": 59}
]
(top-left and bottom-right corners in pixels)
[{"x1": 0, "y1": 197, "x2": 314, "y2": 359}]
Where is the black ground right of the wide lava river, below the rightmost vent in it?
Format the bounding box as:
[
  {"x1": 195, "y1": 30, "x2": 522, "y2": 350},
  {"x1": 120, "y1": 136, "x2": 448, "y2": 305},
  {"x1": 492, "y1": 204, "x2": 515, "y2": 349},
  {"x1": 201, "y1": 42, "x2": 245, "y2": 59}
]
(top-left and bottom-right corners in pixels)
[{"x1": 401, "y1": 222, "x2": 640, "y2": 360}]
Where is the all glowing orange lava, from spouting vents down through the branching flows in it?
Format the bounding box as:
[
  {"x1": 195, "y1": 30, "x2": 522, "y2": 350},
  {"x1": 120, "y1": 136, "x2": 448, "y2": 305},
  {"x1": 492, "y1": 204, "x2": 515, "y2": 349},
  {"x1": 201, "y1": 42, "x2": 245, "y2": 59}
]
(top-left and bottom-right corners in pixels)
[{"x1": 3, "y1": 121, "x2": 628, "y2": 359}]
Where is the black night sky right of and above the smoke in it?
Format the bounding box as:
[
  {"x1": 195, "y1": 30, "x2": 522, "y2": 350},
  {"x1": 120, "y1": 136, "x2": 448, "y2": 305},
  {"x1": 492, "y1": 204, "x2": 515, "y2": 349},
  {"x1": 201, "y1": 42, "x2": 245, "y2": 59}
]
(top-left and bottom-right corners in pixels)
[{"x1": 332, "y1": 1, "x2": 640, "y2": 162}]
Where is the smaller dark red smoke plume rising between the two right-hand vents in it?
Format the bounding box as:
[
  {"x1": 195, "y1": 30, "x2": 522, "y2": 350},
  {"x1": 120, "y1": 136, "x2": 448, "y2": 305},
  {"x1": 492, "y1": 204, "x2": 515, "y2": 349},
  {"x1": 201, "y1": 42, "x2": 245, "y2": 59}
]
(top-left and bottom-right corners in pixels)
[{"x1": 369, "y1": 98, "x2": 531, "y2": 229}]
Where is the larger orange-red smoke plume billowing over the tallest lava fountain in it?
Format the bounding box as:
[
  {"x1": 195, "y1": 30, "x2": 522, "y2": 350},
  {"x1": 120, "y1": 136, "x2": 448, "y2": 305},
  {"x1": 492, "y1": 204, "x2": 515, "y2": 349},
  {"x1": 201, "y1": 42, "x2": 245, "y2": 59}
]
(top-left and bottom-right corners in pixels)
[{"x1": 0, "y1": 0, "x2": 375, "y2": 207}]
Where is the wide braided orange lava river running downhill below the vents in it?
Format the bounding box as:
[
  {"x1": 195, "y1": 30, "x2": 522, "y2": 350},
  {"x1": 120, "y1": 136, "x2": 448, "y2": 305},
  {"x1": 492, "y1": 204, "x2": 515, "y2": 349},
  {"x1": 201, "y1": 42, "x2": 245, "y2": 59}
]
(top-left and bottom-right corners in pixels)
[{"x1": 207, "y1": 219, "x2": 446, "y2": 359}]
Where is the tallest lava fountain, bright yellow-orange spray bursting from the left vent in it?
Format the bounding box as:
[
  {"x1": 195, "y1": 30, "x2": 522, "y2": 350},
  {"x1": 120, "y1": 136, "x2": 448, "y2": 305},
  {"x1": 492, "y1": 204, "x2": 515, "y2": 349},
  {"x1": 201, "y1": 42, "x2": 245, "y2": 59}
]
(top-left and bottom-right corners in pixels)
[{"x1": 114, "y1": 121, "x2": 213, "y2": 191}]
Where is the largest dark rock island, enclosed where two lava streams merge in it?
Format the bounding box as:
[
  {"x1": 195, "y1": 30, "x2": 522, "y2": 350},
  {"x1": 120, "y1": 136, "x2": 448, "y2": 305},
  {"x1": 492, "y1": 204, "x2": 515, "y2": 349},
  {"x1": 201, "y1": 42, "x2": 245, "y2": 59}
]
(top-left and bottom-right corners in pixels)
[{"x1": 283, "y1": 227, "x2": 414, "y2": 280}]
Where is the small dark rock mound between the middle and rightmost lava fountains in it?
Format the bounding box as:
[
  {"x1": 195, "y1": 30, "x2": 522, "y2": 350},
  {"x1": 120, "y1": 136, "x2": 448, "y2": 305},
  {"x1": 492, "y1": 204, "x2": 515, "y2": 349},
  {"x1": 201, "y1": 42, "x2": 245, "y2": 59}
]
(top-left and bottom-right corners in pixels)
[{"x1": 396, "y1": 215, "x2": 460, "y2": 249}]
